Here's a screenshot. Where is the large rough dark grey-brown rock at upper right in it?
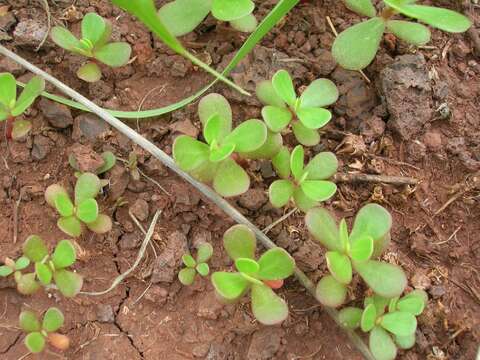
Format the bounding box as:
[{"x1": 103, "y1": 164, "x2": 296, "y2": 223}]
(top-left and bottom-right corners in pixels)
[{"x1": 380, "y1": 54, "x2": 433, "y2": 140}]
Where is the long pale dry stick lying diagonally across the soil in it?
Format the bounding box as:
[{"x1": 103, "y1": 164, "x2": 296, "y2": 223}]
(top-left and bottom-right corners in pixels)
[{"x1": 0, "y1": 45, "x2": 375, "y2": 360}]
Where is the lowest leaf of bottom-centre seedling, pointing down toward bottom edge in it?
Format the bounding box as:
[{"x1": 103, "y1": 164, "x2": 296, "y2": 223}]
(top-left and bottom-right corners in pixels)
[{"x1": 252, "y1": 284, "x2": 288, "y2": 325}]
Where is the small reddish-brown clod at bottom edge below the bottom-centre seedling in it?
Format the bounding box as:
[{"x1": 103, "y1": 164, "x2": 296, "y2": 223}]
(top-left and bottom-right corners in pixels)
[{"x1": 247, "y1": 327, "x2": 283, "y2": 360}]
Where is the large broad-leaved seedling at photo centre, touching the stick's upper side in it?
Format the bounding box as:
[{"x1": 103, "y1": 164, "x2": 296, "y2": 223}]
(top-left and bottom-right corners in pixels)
[{"x1": 173, "y1": 94, "x2": 267, "y2": 197}]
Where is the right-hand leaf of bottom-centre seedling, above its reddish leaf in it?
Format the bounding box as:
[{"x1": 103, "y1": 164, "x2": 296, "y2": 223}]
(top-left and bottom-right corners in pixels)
[{"x1": 258, "y1": 247, "x2": 295, "y2": 280}]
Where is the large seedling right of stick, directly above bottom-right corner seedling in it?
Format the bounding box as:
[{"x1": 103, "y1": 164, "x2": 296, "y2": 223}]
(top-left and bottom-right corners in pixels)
[{"x1": 305, "y1": 204, "x2": 407, "y2": 307}]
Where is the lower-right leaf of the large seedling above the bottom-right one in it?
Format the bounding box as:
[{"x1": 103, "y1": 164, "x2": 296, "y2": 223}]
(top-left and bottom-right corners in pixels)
[{"x1": 353, "y1": 260, "x2": 407, "y2": 298}]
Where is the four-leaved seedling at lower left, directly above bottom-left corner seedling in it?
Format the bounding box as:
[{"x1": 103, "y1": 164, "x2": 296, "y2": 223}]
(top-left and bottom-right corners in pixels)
[{"x1": 14, "y1": 235, "x2": 83, "y2": 297}]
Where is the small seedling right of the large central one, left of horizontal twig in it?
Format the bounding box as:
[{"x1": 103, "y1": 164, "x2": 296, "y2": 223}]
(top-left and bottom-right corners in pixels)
[{"x1": 268, "y1": 145, "x2": 338, "y2": 212}]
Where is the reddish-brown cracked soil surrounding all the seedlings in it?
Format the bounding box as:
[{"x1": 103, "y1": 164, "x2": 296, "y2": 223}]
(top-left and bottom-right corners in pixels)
[{"x1": 0, "y1": 0, "x2": 480, "y2": 360}]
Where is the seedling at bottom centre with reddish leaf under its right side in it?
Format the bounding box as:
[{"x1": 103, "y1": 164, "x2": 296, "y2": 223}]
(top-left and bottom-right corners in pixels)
[{"x1": 212, "y1": 225, "x2": 295, "y2": 325}]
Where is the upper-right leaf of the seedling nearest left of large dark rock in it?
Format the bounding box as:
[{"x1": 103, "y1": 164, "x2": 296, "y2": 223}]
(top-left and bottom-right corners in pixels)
[{"x1": 300, "y1": 79, "x2": 339, "y2": 108}]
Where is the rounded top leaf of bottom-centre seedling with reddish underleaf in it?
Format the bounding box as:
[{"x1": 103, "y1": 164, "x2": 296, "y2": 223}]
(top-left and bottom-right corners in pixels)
[{"x1": 223, "y1": 224, "x2": 257, "y2": 260}]
